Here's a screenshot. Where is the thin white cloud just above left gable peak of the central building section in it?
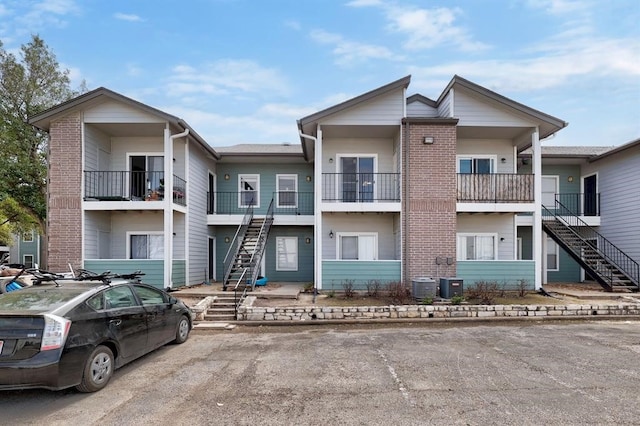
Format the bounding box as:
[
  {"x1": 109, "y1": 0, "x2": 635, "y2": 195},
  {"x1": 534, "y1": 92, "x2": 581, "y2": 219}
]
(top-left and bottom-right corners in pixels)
[{"x1": 310, "y1": 30, "x2": 403, "y2": 66}]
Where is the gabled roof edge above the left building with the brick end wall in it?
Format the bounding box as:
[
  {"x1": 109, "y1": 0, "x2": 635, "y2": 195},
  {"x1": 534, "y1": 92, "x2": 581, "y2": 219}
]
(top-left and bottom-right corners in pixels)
[{"x1": 29, "y1": 87, "x2": 220, "y2": 159}]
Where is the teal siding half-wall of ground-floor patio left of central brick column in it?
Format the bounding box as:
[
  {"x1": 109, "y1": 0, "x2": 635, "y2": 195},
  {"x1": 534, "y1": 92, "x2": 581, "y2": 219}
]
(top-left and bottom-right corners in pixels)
[{"x1": 322, "y1": 260, "x2": 401, "y2": 291}]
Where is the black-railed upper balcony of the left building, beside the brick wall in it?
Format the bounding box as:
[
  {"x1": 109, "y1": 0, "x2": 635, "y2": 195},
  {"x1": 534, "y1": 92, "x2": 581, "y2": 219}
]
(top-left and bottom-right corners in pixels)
[{"x1": 84, "y1": 171, "x2": 187, "y2": 206}]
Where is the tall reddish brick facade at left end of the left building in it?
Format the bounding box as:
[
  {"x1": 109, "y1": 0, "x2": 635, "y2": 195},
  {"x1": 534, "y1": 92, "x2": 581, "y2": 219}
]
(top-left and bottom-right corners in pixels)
[{"x1": 47, "y1": 113, "x2": 82, "y2": 271}]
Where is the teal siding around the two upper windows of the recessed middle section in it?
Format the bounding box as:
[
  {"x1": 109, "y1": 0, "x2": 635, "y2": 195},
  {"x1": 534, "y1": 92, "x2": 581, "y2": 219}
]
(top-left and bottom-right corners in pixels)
[{"x1": 217, "y1": 163, "x2": 313, "y2": 214}]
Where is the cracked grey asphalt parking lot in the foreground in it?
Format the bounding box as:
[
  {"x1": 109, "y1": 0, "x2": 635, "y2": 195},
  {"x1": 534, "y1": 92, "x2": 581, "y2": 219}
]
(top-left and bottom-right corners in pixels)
[{"x1": 0, "y1": 321, "x2": 640, "y2": 425}]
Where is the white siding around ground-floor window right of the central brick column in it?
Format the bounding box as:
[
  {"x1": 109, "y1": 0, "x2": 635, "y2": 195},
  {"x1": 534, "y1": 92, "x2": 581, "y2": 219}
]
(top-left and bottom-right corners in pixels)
[{"x1": 456, "y1": 214, "x2": 516, "y2": 260}]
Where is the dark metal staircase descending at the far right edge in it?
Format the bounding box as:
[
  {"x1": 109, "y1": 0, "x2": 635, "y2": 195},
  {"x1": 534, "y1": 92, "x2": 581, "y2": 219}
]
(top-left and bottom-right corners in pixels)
[{"x1": 542, "y1": 200, "x2": 640, "y2": 291}]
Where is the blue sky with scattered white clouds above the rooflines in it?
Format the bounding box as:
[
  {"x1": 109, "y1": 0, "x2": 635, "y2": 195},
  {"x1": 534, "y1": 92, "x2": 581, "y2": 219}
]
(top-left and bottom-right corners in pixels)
[{"x1": 0, "y1": 0, "x2": 640, "y2": 147}]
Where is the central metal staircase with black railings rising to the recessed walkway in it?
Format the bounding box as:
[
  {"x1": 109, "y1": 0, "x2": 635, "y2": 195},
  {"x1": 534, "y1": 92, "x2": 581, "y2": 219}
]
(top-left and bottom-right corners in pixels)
[{"x1": 222, "y1": 199, "x2": 273, "y2": 311}]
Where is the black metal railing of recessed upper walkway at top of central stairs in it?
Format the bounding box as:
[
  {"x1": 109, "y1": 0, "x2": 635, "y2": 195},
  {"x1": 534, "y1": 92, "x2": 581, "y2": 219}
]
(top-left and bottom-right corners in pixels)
[{"x1": 207, "y1": 191, "x2": 313, "y2": 215}]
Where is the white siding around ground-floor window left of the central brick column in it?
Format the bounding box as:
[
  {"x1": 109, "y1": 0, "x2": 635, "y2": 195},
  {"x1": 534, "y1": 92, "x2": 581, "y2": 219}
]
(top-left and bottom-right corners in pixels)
[{"x1": 322, "y1": 213, "x2": 400, "y2": 260}]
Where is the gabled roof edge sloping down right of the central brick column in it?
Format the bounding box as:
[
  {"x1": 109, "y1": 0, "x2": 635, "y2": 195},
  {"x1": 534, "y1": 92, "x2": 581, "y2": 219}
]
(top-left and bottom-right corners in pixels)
[{"x1": 437, "y1": 75, "x2": 569, "y2": 139}]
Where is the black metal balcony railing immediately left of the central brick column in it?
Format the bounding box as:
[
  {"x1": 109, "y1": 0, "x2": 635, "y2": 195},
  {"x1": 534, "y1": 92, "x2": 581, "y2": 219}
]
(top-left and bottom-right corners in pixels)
[{"x1": 322, "y1": 173, "x2": 400, "y2": 203}]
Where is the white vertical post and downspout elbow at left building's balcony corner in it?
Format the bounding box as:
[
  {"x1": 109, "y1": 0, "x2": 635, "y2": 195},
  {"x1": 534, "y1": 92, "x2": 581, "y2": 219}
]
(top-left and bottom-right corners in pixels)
[{"x1": 164, "y1": 129, "x2": 189, "y2": 289}]
